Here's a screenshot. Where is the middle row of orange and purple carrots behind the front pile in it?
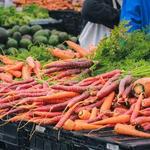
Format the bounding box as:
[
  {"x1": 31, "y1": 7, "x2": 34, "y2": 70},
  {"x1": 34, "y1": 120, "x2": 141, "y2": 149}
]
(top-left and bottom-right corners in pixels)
[{"x1": 0, "y1": 55, "x2": 94, "y2": 84}]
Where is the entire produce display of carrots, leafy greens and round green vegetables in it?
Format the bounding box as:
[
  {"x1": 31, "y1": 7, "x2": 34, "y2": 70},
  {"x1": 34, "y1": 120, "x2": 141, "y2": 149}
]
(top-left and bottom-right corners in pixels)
[{"x1": 0, "y1": 5, "x2": 150, "y2": 148}]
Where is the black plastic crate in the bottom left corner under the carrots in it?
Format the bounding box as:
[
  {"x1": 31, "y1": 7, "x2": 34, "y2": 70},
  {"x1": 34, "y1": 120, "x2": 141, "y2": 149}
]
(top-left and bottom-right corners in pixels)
[{"x1": 0, "y1": 122, "x2": 29, "y2": 150}]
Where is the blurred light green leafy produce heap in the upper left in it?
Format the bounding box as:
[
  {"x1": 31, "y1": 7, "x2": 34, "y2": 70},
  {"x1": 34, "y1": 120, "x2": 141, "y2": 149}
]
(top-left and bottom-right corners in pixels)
[{"x1": 0, "y1": 5, "x2": 49, "y2": 27}]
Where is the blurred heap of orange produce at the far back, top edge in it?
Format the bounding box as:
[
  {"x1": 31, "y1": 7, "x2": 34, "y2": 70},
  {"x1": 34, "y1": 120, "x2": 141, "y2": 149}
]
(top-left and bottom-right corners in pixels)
[{"x1": 13, "y1": 0, "x2": 83, "y2": 11}]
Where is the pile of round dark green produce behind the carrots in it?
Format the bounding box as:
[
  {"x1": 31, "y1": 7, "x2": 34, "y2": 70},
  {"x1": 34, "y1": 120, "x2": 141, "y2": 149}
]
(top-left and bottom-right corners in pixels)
[{"x1": 0, "y1": 25, "x2": 77, "y2": 55}]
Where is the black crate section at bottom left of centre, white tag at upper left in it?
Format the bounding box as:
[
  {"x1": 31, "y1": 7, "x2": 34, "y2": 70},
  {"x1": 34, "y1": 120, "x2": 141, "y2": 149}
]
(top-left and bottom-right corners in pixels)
[{"x1": 30, "y1": 126, "x2": 89, "y2": 150}]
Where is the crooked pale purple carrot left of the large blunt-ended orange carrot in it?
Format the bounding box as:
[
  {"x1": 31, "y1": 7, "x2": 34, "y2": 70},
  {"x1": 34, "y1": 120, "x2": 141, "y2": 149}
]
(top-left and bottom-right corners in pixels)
[{"x1": 118, "y1": 75, "x2": 132, "y2": 97}]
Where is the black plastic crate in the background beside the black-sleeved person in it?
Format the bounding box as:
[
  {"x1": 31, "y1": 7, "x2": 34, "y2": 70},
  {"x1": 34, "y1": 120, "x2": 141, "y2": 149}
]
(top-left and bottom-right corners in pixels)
[{"x1": 49, "y1": 10, "x2": 83, "y2": 36}]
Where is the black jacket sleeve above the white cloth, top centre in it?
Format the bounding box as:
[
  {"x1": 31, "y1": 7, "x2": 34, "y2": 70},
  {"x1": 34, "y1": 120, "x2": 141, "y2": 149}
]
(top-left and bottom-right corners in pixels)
[{"x1": 82, "y1": 0, "x2": 120, "y2": 28}]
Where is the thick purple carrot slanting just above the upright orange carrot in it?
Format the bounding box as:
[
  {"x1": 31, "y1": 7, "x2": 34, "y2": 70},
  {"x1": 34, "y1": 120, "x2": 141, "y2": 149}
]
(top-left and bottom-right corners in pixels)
[{"x1": 97, "y1": 82, "x2": 119, "y2": 99}]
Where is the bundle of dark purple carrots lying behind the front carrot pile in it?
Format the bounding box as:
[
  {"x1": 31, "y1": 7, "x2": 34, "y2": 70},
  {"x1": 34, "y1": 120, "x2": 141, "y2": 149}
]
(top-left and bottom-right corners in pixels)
[{"x1": 42, "y1": 59, "x2": 94, "y2": 83}]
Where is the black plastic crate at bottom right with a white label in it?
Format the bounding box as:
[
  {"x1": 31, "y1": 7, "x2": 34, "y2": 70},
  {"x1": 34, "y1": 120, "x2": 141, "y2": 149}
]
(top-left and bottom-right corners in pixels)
[{"x1": 44, "y1": 128, "x2": 150, "y2": 150}]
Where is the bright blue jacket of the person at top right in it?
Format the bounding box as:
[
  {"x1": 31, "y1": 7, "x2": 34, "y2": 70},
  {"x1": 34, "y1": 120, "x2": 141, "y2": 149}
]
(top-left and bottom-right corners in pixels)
[{"x1": 121, "y1": 0, "x2": 150, "y2": 32}]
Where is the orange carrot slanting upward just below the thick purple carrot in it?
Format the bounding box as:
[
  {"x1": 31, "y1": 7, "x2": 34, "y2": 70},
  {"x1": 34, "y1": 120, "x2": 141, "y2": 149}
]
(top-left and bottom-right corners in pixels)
[{"x1": 100, "y1": 92, "x2": 115, "y2": 112}]
